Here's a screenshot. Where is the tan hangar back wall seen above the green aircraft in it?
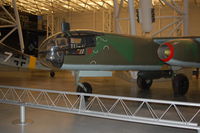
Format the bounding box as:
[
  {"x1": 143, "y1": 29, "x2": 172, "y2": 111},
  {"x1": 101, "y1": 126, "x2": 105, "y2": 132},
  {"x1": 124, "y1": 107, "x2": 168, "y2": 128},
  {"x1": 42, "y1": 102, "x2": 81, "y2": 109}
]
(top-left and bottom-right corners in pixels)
[{"x1": 44, "y1": 3, "x2": 200, "y2": 36}]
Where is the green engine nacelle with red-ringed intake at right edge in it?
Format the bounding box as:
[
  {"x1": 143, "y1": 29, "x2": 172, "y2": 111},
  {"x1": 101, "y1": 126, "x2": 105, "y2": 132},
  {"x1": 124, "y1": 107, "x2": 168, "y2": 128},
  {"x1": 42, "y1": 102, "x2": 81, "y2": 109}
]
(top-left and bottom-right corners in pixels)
[{"x1": 157, "y1": 38, "x2": 200, "y2": 67}]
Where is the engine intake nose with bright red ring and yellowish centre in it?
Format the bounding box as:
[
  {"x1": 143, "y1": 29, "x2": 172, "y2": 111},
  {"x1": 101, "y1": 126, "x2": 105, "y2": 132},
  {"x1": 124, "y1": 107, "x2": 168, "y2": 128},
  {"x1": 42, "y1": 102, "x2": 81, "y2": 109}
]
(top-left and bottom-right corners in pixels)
[{"x1": 157, "y1": 43, "x2": 174, "y2": 62}]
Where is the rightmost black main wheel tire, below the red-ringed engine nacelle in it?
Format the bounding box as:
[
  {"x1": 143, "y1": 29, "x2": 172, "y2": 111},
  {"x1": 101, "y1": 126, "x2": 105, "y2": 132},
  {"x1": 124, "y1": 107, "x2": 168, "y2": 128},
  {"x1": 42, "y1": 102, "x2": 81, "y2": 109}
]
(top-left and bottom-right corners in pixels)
[{"x1": 172, "y1": 74, "x2": 189, "y2": 96}]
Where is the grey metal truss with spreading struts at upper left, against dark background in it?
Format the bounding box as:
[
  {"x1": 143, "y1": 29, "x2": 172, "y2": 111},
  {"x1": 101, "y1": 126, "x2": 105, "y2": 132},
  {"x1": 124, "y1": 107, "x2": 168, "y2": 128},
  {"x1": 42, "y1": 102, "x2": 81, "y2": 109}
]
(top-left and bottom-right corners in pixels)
[{"x1": 0, "y1": 0, "x2": 24, "y2": 52}]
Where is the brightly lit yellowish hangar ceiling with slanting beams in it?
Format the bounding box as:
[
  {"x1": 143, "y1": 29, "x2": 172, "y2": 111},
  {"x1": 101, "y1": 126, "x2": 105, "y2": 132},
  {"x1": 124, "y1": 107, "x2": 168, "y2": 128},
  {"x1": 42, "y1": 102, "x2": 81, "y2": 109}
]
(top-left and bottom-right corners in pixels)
[{"x1": 0, "y1": 0, "x2": 199, "y2": 15}]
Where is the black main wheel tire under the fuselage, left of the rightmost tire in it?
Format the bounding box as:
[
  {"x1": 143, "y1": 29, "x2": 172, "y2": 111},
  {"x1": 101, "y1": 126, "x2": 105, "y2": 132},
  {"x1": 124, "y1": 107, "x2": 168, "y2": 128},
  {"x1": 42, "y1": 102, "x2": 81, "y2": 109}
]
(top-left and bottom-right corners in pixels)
[{"x1": 137, "y1": 76, "x2": 153, "y2": 90}]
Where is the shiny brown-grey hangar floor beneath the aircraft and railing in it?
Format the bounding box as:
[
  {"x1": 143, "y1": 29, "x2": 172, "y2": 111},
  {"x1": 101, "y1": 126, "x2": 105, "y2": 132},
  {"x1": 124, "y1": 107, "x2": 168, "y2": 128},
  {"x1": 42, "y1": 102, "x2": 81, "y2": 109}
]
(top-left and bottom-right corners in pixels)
[{"x1": 0, "y1": 69, "x2": 200, "y2": 133}]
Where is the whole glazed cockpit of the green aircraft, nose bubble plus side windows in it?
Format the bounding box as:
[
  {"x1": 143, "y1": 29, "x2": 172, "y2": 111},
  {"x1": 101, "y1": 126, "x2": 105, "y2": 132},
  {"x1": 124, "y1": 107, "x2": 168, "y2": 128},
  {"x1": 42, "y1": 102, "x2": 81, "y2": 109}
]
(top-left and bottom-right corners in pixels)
[{"x1": 38, "y1": 31, "x2": 97, "y2": 69}]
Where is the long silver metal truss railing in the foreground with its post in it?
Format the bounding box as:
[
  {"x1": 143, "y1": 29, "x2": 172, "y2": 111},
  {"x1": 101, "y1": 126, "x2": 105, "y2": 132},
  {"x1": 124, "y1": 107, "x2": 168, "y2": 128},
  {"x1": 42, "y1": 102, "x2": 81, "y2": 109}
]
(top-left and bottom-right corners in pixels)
[{"x1": 0, "y1": 86, "x2": 200, "y2": 132}]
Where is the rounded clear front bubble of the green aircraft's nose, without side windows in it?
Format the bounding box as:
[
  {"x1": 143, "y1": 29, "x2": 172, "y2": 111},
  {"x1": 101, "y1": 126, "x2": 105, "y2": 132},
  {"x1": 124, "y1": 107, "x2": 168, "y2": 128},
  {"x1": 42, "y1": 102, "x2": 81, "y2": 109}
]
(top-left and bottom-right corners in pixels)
[{"x1": 38, "y1": 33, "x2": 68, "y2": 69}]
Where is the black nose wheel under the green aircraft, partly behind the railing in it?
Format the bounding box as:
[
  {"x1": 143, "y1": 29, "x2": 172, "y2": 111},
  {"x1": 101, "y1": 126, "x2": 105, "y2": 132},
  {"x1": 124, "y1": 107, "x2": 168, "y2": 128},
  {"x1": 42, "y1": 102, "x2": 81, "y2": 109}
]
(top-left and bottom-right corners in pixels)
[{"x1": 76, "y1": 82, "x2": 92, "y2": 101}]
